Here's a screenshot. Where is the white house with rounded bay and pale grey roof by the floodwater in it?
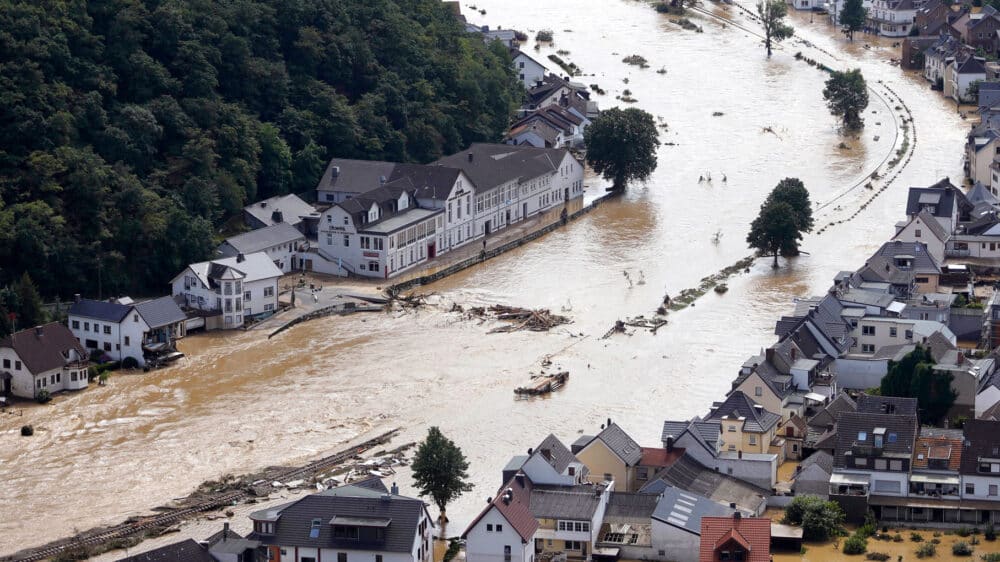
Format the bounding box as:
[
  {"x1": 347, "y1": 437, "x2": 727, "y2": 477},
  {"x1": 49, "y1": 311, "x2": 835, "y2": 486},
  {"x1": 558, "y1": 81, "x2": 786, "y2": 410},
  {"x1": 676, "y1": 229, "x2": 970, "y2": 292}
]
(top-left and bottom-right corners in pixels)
[{"x1": 170, "y1": 252, "x2": 282, "y2": 329}]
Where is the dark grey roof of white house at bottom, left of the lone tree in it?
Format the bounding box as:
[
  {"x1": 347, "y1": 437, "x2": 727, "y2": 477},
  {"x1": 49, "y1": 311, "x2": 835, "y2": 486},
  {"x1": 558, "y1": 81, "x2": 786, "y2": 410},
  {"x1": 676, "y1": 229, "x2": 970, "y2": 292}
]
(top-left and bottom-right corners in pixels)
[{"x1": 250, "y1": 486, "x2": 425, "y2": 553}]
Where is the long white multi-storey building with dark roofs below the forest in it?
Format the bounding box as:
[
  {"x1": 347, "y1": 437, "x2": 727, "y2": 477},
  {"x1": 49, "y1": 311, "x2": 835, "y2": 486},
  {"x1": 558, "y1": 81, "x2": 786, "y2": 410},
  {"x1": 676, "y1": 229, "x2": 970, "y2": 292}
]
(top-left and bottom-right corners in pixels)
[{"x1": 316, "y1": 144, "x2": 583, "y2": 278}]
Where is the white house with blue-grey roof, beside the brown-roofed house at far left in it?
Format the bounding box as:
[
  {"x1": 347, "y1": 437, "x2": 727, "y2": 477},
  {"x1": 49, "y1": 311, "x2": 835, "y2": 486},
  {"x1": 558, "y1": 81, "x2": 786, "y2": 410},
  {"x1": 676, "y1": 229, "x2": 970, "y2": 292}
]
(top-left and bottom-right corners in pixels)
[{"x1": 66, "y1": 297, "x2": 187, "y2": 367}]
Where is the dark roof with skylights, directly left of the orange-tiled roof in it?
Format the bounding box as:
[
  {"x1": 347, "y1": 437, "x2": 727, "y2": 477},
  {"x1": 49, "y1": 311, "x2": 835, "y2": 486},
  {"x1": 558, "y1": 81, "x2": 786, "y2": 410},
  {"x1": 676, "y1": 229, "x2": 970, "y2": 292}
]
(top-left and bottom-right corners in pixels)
[{"x1": 834, "y1": 411, "x2": 917, "y2": 468}]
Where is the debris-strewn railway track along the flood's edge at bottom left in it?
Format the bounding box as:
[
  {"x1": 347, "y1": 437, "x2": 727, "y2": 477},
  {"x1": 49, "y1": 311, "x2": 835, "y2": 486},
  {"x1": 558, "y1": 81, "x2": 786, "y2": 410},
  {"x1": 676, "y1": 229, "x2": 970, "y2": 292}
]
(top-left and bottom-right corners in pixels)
[{"x1": 8, "y1": 428, "x2": 399, "y2": 562}]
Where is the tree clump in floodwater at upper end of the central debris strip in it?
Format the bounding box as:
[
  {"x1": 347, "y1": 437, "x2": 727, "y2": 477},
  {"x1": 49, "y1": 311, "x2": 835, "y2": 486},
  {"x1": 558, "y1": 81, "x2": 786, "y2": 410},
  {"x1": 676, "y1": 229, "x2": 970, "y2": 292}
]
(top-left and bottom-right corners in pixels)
[{"x1": 747, "y1": 178, "x2": 813, "y2": 267}]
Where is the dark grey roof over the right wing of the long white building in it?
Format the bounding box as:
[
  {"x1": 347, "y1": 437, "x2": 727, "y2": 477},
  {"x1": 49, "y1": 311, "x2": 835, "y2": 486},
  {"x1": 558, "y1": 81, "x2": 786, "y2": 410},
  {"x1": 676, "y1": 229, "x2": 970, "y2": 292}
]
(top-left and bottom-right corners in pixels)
[{"x1": 434, "y1": 143, "x2": 568, "y2": 192}]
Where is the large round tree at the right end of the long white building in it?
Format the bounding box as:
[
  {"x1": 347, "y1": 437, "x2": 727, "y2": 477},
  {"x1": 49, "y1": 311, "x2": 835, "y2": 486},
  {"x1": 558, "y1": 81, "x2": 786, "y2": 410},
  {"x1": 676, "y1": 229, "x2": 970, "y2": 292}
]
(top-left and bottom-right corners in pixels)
[{"x1": 584, "y1": 107, "x2": 660, "y2": 191}]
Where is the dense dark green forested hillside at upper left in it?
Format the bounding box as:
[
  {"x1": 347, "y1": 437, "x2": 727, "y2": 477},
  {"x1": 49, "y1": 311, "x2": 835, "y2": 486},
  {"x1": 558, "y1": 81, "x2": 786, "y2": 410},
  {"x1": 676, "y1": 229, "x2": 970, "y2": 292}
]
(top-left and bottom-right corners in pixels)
[{"x1": 0, "y1": 0, "x2": 521, "y2": 302}]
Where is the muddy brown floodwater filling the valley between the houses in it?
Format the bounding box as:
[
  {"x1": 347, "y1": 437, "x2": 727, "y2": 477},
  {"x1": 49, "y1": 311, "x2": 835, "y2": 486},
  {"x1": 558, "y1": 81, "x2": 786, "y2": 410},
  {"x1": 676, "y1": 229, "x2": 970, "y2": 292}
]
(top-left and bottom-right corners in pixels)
[{"x1": 0, "y1": 0, "x2": 965, "y2": 552}]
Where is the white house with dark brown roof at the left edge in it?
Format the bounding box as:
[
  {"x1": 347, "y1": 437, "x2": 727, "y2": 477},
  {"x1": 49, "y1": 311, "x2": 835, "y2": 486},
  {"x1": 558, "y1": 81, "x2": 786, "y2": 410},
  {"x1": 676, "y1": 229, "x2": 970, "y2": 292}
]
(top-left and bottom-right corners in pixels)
[{"x1": 0, "y1": 322, "x2": 89, "y2": 398}]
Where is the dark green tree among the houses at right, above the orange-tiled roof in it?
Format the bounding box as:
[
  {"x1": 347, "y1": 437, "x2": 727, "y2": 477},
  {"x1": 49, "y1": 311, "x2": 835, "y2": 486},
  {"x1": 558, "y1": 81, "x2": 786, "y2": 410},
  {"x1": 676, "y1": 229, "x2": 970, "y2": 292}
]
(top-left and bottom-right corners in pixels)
[{"x1": 880, "y1": 345, "x2": 958, "y2": 425}]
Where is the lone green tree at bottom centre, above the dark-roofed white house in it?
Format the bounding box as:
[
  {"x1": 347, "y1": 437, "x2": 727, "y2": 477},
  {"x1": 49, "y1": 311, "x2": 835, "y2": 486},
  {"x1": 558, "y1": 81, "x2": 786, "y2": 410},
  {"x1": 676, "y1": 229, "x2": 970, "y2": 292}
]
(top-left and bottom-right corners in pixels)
[{"x1": 413, "y1": 427, "x2": 472, "y2": 520}]
